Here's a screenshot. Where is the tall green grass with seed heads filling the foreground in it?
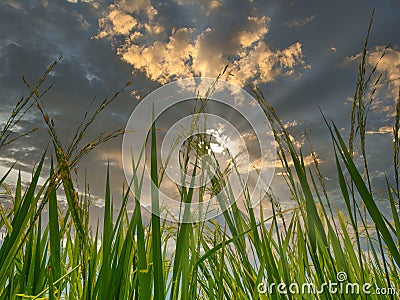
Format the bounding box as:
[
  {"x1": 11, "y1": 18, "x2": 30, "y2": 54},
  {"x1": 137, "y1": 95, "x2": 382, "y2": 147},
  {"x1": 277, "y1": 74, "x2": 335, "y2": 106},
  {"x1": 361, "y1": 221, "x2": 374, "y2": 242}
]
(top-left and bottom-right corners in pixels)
[{"x1": 0, "y1": 16, "x2": 400, "y2": 300}]
